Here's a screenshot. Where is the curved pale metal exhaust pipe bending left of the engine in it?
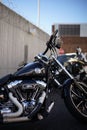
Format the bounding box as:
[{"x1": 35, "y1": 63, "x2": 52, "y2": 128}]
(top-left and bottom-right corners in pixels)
[{"x1": 3, "y1": 93, "x2": 23, "y2": 119}]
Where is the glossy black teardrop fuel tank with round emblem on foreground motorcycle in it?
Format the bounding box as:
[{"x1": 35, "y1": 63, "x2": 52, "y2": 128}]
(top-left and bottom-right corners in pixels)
[{"x1": 14, "y1": 62, "x2": 45, "y2": 77}]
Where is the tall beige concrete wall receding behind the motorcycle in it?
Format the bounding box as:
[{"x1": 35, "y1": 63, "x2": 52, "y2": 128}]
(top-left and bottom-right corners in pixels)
[{"x1": 0, "y1": 3, "x2": 49, "y2": 77}]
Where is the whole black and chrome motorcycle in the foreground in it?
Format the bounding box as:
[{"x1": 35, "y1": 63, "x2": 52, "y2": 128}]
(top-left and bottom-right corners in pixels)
[{"x1": 0, "y1": 30, "x2": 87, "y2": 123}]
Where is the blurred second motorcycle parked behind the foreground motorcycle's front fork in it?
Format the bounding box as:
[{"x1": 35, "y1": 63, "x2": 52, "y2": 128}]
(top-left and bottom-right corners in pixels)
[{"x1": 64, "y1": 55, "x2": 87, "y2": 84}]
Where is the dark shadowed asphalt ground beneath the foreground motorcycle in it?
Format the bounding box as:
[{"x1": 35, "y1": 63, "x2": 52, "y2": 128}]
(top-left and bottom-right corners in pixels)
[{"x1": 0, "y1": 91, "x2": 87, "y2": 130}]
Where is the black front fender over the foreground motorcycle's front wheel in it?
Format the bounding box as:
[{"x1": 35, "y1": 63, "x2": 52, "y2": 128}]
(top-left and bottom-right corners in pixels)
[{"x1": 62, "y1": 79, "x2": 73, "y2": 98}]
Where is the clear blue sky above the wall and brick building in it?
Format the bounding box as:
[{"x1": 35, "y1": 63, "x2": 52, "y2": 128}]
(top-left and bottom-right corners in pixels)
[{"x1": 0, "y1": 0, "x2": 87, "y2": 35}]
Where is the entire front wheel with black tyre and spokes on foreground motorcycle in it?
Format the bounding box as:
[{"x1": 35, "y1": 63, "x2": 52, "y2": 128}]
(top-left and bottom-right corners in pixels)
[{"x1": 64, "y1": 82, "x2": 87, "y2": 123}]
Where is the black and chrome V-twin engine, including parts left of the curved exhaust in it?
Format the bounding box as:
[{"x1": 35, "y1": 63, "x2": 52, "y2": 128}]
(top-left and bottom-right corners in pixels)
[{"x1": 0, "y1": 80, "x2": 46, "y2": 116}]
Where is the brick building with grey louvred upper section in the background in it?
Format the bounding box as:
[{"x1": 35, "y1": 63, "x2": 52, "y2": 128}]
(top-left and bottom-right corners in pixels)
[{"x1": 52, "y1": 24, "x2": 87, "y2": 53}]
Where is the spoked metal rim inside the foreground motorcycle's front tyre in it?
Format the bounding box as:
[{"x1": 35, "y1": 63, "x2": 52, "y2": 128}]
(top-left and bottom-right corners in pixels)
[{"x1": 70, "y1": 83, "x2": 87, "y2": 117}]
